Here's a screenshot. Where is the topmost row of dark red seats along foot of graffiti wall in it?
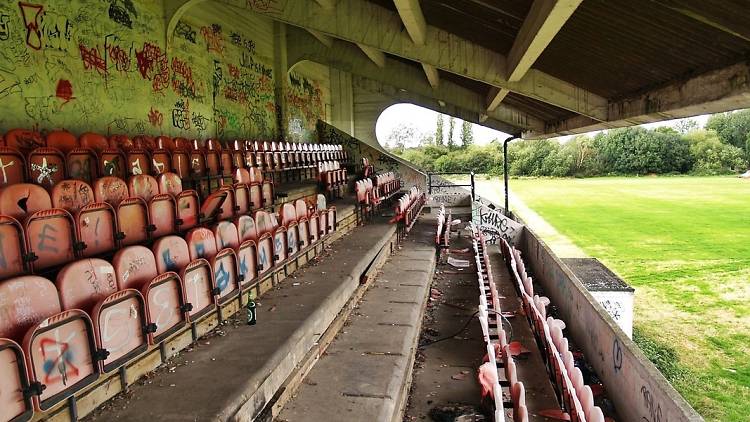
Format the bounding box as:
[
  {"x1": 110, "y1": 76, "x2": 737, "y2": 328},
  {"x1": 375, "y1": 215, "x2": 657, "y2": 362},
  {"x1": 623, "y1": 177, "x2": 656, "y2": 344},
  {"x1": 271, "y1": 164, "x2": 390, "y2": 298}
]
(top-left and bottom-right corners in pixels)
[{"x1": 0, "y1": 129, "x2": 348, "y2": 188}]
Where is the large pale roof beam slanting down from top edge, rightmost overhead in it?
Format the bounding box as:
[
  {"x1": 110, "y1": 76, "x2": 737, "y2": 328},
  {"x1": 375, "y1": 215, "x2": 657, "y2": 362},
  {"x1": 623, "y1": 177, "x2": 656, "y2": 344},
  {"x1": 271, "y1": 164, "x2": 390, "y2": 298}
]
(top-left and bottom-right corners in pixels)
[{"x1": 487, "y1": 0, "x2": 583, "y2": 110}]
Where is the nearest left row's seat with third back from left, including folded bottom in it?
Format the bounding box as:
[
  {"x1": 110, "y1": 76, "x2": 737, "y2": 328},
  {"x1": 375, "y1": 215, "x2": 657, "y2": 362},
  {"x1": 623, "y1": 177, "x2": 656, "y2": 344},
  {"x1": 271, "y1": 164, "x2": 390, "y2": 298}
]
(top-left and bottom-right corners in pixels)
[{"x1": 112, "y1": 246, "x2": 188, "y2": 344}]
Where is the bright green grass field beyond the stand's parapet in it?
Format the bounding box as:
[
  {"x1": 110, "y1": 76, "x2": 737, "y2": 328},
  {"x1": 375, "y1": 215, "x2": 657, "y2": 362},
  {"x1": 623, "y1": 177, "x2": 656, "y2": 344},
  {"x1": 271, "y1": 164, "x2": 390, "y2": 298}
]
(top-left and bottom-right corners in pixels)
[{"x1": 510, "y1": 177, "x2": 750, "y2": 421}]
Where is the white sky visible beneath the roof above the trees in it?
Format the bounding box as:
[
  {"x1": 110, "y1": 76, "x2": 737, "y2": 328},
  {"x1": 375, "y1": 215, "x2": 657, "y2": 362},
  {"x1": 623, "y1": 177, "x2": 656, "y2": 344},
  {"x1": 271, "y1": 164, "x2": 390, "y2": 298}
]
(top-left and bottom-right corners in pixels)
[{"x1": 375, "y1": 104, "x2": 709, "y2": 146}]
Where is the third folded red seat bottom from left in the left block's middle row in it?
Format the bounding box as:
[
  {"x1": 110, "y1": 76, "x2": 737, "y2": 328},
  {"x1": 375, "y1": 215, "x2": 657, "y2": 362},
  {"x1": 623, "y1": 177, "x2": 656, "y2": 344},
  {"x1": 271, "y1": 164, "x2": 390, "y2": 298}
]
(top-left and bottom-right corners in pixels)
[{"x1": 74, "y1": 202, "x2": 119, "y2": 257}]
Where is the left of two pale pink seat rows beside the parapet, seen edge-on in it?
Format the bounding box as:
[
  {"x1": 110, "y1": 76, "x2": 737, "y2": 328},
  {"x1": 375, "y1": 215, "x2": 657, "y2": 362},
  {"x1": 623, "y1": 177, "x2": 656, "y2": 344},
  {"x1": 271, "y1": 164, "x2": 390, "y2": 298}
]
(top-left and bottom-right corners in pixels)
[{"x1": 470, "y1": 223, "x2": 529, "y2": 422}]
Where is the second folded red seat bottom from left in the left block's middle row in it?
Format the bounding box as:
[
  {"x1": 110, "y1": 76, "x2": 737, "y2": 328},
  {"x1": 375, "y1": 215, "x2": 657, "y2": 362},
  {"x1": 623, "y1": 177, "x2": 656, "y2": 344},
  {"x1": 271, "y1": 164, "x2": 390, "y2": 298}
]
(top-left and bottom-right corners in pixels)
[{"x1": 25, "y1": 208, "x2": 80, "y2": 272}]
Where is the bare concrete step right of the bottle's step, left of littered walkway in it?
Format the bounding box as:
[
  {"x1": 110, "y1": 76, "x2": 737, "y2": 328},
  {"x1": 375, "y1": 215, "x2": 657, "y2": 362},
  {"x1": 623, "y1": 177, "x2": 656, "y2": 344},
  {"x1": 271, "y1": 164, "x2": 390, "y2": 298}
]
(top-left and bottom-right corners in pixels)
[{"x1": 278, "y1": 221, "x2": 435, "y2": 422}]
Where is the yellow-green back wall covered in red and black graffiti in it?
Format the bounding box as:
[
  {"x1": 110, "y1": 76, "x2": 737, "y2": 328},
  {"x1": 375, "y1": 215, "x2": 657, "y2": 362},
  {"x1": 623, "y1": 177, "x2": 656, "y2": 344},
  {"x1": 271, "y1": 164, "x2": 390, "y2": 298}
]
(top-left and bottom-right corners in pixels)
[{"x1": 0, "y1": 0, "x2": 330, "y2": 141}]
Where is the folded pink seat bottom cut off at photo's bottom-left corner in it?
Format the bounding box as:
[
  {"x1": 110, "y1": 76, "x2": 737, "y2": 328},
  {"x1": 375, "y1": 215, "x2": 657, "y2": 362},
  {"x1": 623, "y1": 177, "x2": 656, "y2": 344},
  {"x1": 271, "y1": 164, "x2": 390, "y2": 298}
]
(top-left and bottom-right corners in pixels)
[{"x1": 0, "y1": 338, "x2": 33, "y2": 422}]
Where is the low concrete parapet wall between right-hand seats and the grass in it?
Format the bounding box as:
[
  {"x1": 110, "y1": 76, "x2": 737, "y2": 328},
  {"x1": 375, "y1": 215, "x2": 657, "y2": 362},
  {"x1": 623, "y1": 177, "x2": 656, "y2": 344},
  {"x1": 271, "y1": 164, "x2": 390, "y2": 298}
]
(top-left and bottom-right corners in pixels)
[{"x1": 516, "y1": 227, "x2": 703, "y2": 422}]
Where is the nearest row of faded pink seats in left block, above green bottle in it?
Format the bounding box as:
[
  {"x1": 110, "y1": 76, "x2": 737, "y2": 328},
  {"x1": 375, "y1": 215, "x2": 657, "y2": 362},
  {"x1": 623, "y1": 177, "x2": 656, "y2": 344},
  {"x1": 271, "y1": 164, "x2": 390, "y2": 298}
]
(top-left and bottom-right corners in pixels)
[{"x1": 0, "y1": 195, "x2": 336, "y2": 422}]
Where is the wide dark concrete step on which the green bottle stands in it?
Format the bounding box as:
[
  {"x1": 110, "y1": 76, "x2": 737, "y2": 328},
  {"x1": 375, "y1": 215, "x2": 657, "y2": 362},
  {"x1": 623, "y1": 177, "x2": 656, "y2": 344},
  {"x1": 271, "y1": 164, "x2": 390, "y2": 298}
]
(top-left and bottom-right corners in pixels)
[{"x1": 83, "y1": 219, "x2": 396, "y2": 421}]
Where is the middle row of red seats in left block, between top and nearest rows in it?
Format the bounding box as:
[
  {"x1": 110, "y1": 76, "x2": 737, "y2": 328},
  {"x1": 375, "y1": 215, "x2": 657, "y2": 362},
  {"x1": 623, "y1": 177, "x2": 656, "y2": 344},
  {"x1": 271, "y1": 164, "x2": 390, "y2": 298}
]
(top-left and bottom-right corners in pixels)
[{"x1": 0, "y1": 169, "x2": 280, "y2": 279}]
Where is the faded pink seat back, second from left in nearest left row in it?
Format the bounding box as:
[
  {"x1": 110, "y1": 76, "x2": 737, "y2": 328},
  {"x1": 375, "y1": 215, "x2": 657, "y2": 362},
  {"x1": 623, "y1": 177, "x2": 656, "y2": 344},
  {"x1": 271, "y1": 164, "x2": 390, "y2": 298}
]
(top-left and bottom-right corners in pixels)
[{"x1": 55, "y1": 258, "x2": 117, "y2": 314}]
